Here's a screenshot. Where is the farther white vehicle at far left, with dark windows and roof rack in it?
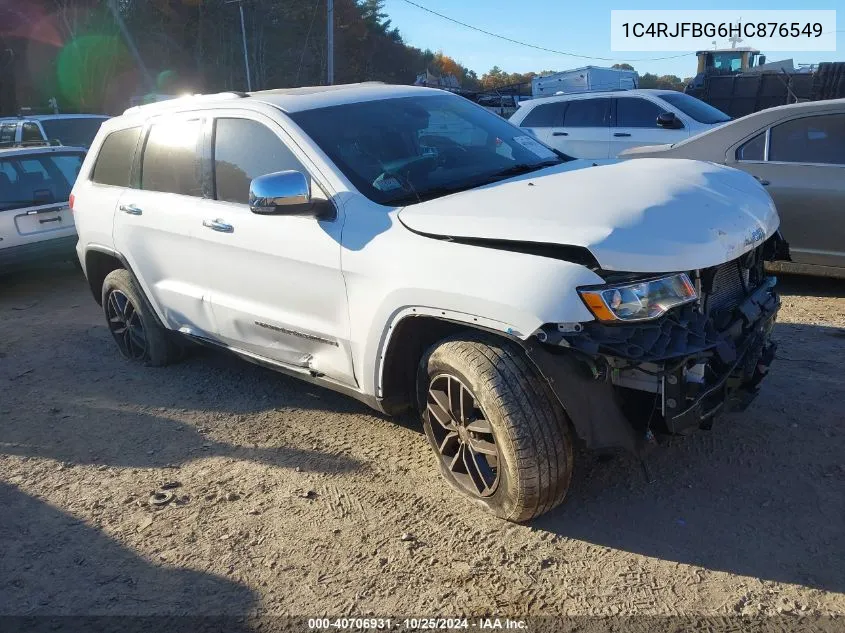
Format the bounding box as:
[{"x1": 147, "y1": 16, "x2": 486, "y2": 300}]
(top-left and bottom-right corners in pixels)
[{"x1": 0, "y1": 114, "x2": 109, "y2": 147}]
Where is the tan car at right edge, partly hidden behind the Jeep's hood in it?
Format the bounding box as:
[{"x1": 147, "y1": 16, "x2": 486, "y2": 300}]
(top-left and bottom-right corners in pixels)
[{"x1": 619, "y1": 99, "x2": 845, "y2": 277}]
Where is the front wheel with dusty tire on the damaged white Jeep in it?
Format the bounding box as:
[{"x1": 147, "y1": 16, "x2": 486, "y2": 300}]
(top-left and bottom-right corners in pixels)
[{"x1": 417, "y1": 332, "x2": 573, "y2": 522}]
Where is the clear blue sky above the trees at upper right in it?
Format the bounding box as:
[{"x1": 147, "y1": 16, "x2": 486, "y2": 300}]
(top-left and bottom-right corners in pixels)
[{"x1": 385, "y1": 0, "x2": 845, "y2": 78}]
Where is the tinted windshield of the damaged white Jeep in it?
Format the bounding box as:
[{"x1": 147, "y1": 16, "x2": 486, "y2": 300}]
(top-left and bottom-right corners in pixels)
[{"x1": 290, "y1": 94, "x2": 570, "y2": 205}]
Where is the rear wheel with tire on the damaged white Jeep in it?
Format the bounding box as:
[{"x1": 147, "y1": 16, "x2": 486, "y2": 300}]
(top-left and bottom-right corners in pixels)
[{"x1": 103, "y1": 268, "x2": 182, "y2": 367}]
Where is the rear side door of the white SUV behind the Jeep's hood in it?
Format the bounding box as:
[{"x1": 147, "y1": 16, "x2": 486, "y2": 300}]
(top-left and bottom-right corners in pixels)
[{"x1": 559, "y1": 97, "x2": 611, "y2": 158}]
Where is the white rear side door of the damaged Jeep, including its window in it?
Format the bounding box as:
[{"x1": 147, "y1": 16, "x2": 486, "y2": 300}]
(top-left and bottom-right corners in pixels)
[{"x1": 114, "y1": 114, "x2": 214, "y2": 337}]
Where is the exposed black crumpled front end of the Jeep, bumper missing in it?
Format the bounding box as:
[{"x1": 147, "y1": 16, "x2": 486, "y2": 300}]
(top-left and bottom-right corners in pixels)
[{"x1": 527, "y1": 234, "x2": 785, "y2": 453}]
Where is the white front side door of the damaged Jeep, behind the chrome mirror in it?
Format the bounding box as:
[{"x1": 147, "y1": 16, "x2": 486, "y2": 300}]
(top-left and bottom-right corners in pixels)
[{"x1": 194, "y1": 112, "x2": 355, "y2": 385}]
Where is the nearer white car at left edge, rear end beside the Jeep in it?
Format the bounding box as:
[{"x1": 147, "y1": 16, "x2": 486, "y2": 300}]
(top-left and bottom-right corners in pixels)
[{"x1": 0, "y1": 147, "x2": 85, "y2": 273}]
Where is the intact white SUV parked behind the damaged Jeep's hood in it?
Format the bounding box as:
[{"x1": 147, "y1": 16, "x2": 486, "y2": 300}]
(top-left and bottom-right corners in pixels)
[{"x1": 510, "y1": 90, "x2": 731, "y2": 159}]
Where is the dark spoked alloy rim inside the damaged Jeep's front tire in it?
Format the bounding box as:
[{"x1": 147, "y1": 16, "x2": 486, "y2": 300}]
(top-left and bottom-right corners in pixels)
[{"x1": 426, "y1": 374, "x2": 500, "y2": 497}]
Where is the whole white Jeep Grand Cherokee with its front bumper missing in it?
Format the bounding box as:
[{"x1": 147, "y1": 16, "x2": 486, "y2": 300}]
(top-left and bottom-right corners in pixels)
[{"x1": 73, "y1": 84, "x2": 785, "y2": 521}]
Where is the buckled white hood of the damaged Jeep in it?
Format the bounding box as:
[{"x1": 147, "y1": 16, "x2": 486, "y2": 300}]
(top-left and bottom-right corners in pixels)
[{"x1": 399, "y1": 158, "x2": 780, "y2": 273}]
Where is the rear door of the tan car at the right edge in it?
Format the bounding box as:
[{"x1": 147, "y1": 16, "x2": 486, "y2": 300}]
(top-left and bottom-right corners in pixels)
[{"x1": 734, "y1": 114, "x2": 845, "y2": 267}]
